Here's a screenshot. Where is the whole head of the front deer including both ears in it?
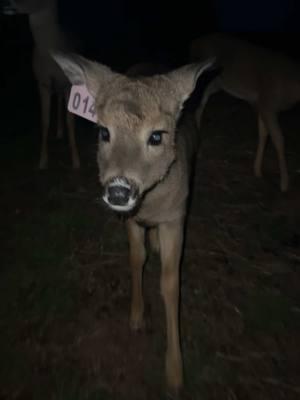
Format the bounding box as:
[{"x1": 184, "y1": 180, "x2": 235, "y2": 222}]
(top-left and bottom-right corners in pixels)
[{"x1": 54, "y1": 55, "x2": 212, "y2": 212}]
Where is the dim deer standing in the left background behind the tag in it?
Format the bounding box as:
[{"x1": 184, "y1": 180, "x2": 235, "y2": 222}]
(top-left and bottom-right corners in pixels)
[{"x1": 14, "y1": 0, "x2": 80, "y2": 169}]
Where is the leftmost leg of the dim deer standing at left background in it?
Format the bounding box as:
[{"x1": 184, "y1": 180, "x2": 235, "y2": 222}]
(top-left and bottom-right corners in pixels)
[{"x1": 38, "y1": 83, "x2": 51, "y2": 169}]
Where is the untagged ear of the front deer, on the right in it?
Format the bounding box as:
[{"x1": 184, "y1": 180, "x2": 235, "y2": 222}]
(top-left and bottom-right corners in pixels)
[{"x1": 167, "y1": 58, "x2": 215, "y2": 108}]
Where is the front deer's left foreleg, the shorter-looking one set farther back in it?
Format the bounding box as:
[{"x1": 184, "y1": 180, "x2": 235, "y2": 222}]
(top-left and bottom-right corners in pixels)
[{"x1": 127, "y1": 219, "x2": 146, "y2": 331}]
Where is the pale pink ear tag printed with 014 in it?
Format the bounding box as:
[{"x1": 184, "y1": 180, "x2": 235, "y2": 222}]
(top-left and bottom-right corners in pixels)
[{"x1": 68, "y1": 85, "x2": 97, "y2": 122}]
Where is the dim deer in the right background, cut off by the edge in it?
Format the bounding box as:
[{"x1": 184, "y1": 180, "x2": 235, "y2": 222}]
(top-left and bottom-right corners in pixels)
[{"x1": 189, "y1": 33, "x2": 300, "y2": 192}]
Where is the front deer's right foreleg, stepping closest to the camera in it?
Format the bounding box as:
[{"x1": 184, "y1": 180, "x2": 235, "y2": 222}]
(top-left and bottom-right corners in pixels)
[{"x1": 159, "y1": 220, "x2": 183, "y2": 395}]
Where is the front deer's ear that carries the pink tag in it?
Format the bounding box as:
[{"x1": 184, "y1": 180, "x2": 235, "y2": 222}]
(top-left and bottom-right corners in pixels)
[{"x1": 52, "y1": 53, "x2": 118, "y2": 98}]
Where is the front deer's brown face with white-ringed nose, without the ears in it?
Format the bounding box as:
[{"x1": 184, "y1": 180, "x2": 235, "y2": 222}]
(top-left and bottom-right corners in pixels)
[{"x1": 97, "y1": 78, "x2": 176, "y2": 212}]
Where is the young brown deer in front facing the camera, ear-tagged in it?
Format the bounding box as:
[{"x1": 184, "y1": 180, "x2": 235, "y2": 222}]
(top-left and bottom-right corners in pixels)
[{"x1": 53, "y1": 53, "x2": 214, "y2": 395}]
